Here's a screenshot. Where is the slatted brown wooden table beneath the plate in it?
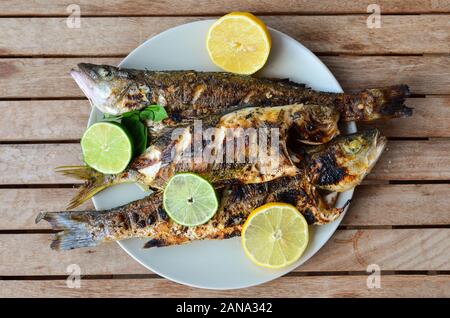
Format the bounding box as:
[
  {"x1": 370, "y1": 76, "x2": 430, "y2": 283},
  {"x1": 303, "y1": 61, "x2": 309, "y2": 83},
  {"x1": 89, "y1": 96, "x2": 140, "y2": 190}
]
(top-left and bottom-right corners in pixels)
[{"x1": 0, "y1": 0, "x2": 450, "y2": 297}]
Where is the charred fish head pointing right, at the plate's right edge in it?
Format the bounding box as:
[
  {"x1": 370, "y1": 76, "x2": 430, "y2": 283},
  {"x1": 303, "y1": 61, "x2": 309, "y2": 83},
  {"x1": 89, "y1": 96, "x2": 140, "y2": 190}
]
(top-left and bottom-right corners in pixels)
[{"x1": 308, "y1": 129, "x2": 386, "y2": 192}]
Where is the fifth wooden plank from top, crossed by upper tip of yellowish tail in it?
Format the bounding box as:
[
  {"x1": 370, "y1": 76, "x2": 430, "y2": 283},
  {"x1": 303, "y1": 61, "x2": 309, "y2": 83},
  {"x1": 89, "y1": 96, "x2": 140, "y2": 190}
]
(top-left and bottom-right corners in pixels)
[{"x1": 0, "y1": 140, "x2": 450, "y2": 184}]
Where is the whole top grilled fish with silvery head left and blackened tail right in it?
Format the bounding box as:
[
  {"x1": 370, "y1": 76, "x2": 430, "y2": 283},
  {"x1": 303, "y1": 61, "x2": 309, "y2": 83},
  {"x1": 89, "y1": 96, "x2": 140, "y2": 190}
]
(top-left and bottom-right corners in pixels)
[{"x1": 71, "y1": 63, "x2": 412, "y2": 121}]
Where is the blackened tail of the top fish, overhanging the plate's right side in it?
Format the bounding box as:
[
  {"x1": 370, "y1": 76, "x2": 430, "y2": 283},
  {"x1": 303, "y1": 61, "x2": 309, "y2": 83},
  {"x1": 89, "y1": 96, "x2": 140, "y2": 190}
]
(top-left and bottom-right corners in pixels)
[{"x1": 340, "y1": 85, "x2": 413, "y2": 121}]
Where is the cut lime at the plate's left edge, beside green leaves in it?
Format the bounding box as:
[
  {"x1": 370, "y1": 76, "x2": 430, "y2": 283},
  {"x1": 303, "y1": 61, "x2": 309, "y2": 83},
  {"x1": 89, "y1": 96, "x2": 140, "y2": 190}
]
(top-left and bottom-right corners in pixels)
[{"x1": 81, "y1": 122, "x2": 133, "y2": 174}]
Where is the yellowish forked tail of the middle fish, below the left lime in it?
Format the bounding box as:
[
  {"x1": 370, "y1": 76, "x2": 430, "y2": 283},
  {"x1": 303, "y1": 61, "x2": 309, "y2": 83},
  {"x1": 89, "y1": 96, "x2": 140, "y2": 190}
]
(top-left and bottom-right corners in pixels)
[{"x1": 56, "y1": 166, "x2": 116, "y2": 210}]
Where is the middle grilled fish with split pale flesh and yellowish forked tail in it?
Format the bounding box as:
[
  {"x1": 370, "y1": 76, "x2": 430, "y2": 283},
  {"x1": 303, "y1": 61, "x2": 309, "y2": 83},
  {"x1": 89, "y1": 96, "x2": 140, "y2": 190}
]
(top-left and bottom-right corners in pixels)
[{"x1": 59, "y1": 104, "x2": 339, "y2": 208}]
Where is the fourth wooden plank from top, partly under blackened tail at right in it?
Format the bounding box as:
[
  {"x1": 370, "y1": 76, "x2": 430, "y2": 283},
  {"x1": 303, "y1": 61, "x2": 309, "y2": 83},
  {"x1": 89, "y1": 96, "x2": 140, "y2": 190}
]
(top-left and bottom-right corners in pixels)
[{"x1": 0, "y1": 96, "x2": 450, "y2": 142}]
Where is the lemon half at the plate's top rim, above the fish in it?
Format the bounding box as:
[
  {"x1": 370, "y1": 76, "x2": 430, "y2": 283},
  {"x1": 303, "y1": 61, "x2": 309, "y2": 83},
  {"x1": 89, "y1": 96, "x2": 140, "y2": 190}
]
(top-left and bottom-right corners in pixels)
[{"x1": 206, "y1": 12, "x2": 271, "y2": 75}]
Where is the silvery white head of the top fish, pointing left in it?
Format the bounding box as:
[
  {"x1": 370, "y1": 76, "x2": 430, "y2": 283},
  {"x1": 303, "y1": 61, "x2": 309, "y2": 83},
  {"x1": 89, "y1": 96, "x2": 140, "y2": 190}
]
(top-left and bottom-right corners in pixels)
[{"x1": 70, "y1": 63, "x2": 151, "y2": 115}]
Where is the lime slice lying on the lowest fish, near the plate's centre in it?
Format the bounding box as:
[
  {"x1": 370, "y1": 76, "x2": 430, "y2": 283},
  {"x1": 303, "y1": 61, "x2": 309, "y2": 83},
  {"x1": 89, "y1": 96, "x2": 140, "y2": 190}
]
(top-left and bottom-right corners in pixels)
[{"x1": 163, "y1": 173, "x2": 219, "y2": 226}]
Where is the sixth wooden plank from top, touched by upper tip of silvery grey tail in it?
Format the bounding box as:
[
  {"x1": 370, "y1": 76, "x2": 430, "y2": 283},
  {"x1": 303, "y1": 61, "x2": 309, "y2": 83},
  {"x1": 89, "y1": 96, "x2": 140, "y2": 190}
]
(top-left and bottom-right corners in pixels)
[{"x1": 0, "y1": 184, "x2": 450, "y2": 230}]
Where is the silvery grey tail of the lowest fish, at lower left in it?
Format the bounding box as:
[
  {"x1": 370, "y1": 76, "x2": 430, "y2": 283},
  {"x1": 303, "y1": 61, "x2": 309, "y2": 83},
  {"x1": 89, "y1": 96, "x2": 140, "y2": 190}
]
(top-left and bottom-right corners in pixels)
[{"x1": 36, "y1": 211, "x2": 102, "y2": 251}]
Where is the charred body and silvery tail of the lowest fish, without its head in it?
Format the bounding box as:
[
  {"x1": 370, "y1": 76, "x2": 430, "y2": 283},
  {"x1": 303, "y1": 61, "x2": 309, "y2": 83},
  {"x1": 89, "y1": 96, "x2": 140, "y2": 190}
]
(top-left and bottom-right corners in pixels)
[{"x1": 36, "y1": 175, "x2": 343, "y2": 250}]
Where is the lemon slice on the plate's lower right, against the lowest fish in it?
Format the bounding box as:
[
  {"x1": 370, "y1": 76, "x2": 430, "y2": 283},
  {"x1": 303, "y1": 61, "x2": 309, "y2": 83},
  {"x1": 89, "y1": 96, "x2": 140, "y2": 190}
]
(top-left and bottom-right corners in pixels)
[{"x1": 242, "y1": 203, "x2": 309, "y2": 268}]
